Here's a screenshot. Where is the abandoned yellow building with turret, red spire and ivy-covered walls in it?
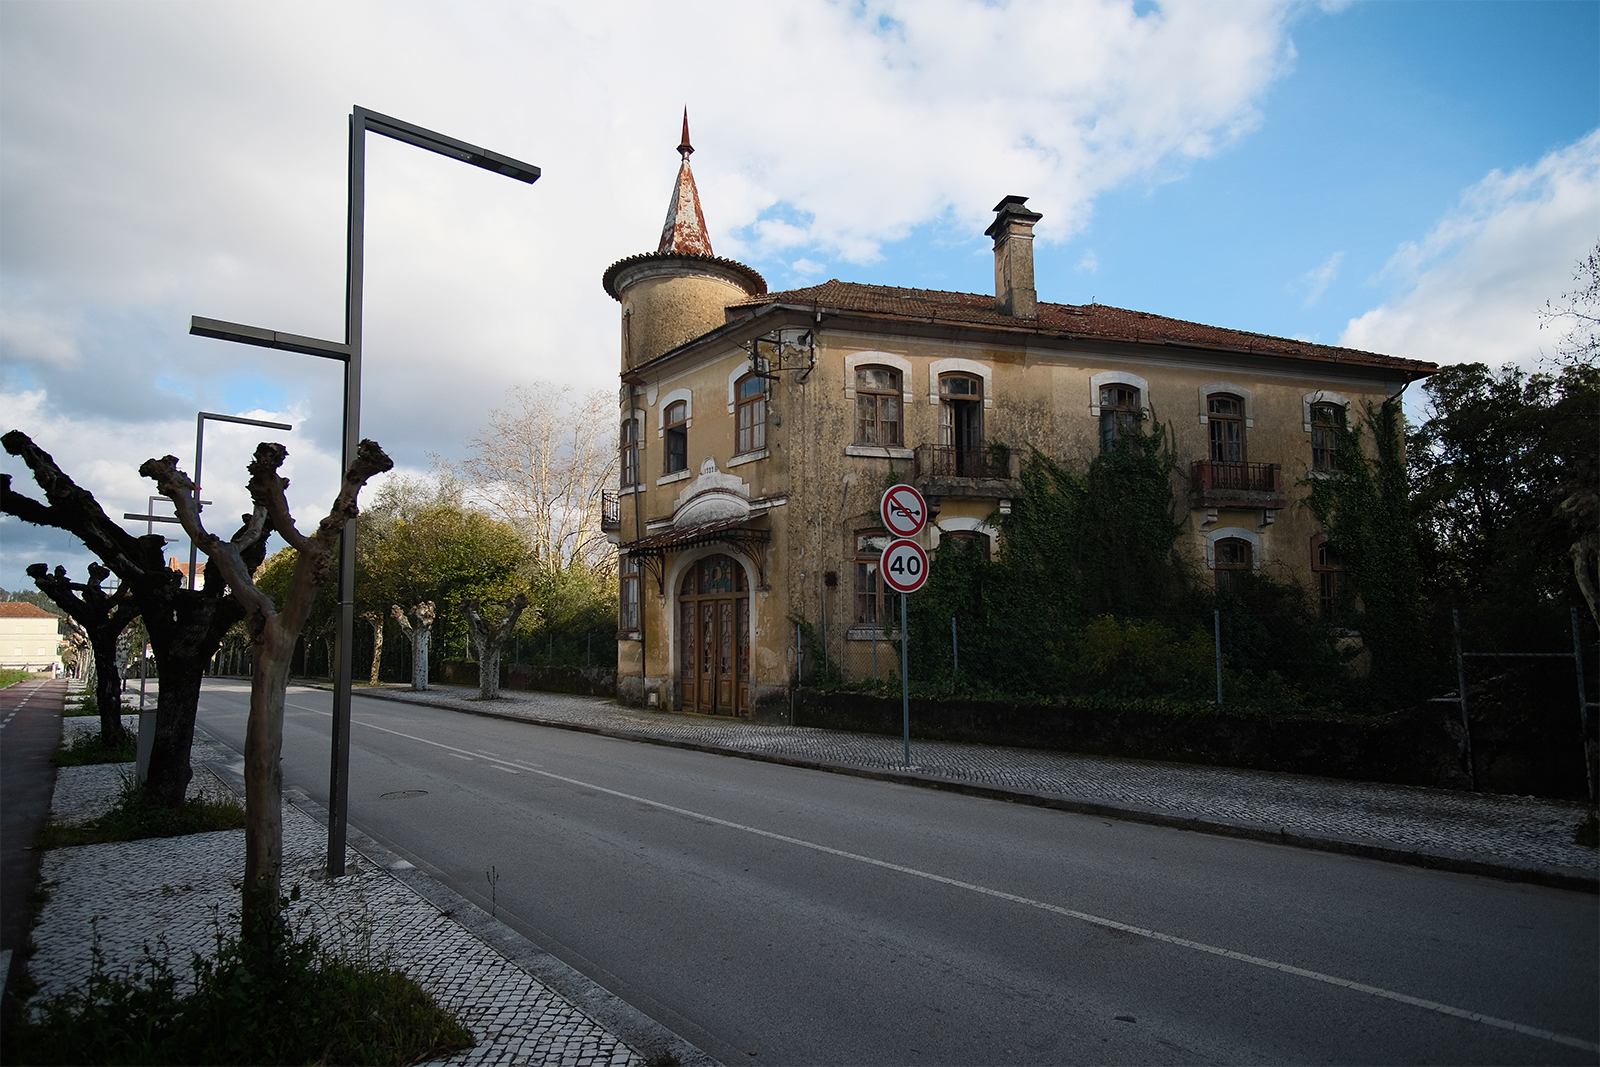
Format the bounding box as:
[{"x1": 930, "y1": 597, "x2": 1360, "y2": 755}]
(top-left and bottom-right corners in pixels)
[{"x1": 603, "y1": 120, "x2": 1435, "y2": 717}]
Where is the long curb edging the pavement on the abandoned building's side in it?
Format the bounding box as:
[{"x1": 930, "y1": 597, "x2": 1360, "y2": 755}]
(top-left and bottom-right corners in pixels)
[{"x1": 324, "y1": 683, "x2": 1600, "y2": 894}]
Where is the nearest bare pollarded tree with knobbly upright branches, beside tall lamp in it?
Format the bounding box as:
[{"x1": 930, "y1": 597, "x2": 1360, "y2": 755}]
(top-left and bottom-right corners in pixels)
[{"x1": 139, "y1": 440, "x2": 394, "y2": 949}]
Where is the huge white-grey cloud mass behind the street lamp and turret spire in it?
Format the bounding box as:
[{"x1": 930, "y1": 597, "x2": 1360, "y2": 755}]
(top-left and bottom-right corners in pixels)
[{"x1": 0, "y1": 0, "x2": 1291, "y2": 584}]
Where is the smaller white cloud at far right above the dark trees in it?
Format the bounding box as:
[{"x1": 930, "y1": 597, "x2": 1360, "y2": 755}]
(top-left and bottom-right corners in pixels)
[{"x1": 1339, "y1": 130, "x2": 1600, "y2": 370}]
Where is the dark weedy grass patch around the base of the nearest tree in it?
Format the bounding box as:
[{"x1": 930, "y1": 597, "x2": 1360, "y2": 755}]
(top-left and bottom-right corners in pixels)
[{"x1": 3, "y1": 931, "x2": 474, "y2": 1064}]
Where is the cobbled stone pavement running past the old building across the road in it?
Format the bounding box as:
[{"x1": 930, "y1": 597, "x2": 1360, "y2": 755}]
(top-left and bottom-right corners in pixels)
[{"x1": 334, "y1": 686, "x2": 1600, "y2": 886}]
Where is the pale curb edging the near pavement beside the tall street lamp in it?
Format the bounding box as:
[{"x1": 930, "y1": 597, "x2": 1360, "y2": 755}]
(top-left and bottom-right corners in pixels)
[{"x1": 195, "y1": 726, "x2": 722, "y2": 1067}]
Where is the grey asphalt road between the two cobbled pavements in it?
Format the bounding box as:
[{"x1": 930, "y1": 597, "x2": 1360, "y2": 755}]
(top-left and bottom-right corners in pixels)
[{"x1": 200, "y1": 681, "x2": 1600, "y2": 1064}]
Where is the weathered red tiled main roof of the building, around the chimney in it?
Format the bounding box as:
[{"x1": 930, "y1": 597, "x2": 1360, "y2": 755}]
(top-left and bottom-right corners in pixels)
[{"x1": 730, "y1": 278, "x2": 1438, "y2": 378}]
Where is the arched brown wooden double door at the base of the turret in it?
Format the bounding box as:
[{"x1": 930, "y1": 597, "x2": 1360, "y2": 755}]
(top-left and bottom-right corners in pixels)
[{"x1": 678, "y1": 555, "x2": 750, "y2": 715}]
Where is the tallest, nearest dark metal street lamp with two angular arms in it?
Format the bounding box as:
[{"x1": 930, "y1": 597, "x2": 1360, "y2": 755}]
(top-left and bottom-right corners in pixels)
[{"x1": 189, "y1": 107, "x2": 539, "y2": 878}]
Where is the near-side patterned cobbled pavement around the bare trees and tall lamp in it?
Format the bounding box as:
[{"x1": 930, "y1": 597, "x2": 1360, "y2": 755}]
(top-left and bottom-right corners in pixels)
[{"x1": 17, "y1": 700, "x2": 712, "y2": 1067}]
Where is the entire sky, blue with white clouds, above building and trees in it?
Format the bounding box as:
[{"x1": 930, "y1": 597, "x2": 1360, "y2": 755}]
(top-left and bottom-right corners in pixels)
[{"x1": 0, "y1": 0, "x2": 1600, "y2": 589}]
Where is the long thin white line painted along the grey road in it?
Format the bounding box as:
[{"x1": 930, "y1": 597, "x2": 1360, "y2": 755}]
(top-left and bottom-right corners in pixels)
[{"x1": 305, "y1": 705, "x2": 1600, "y2": 1053}]
